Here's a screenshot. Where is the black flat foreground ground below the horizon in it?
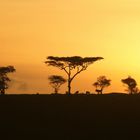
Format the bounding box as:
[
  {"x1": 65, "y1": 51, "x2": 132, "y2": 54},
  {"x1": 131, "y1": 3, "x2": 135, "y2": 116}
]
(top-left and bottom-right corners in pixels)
[{"x1": 0, "y1": 94, "x2": 140, "y2": 140}]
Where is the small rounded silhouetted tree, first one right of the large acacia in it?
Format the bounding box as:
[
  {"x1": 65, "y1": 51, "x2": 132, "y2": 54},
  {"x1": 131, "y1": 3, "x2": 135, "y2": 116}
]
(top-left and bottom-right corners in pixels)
[{"x1": 93, "y1": 76, "x2": 111, "y2": 94}]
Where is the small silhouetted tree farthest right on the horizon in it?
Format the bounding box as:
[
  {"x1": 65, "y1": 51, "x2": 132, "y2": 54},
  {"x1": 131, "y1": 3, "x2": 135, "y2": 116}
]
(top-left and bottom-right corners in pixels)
[{"x1": 121, "y1": 76, "x2": 139, "y2": 94}]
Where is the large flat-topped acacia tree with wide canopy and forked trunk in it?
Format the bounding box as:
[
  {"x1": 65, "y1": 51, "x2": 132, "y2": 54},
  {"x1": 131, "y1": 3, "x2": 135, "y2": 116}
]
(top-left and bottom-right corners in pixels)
[{"x1": 45, "y1": 56, "x2": 103, "y2": 94}]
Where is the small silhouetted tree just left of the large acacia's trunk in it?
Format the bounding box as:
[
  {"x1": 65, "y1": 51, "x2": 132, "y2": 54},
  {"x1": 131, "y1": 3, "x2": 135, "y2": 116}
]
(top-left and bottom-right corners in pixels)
[{"x1": 48, "y1": 75, "x2": 66, "y2": 94}]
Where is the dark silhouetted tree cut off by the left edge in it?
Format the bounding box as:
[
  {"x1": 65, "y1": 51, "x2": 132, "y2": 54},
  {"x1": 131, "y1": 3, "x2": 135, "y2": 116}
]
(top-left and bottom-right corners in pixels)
[{"x1": 0, "y1": 66, "x2": 16, "y2": 94}]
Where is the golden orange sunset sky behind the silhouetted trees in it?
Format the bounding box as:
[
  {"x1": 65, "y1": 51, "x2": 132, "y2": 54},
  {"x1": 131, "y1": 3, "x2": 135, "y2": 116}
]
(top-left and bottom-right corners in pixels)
[{"x1": 0, "y1": 0, "x2": 140, "y2": 93}]
